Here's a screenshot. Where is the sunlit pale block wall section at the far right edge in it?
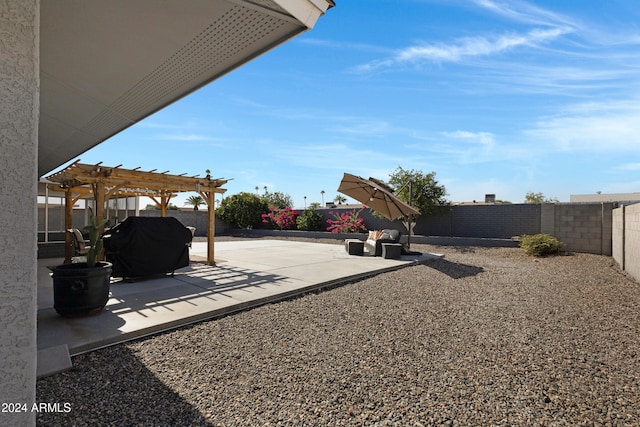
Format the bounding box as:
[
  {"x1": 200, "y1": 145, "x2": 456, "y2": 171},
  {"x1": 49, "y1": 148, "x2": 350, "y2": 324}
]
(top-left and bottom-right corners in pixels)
[{"x1": 613, "y1": 204, "x2": 640, "y2": 280}]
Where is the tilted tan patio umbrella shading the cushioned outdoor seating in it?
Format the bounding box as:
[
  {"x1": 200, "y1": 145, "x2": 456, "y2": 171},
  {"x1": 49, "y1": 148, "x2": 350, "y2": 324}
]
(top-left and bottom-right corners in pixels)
[{"x1": 338, "y1": 173, "x2": 420, "y2": 251}]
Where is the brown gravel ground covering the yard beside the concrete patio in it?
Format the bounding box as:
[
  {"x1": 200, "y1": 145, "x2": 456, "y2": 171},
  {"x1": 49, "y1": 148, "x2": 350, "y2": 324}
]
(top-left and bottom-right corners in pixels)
[{"x1": 37, "y1": 239, "x2": 640, "y2": 426}]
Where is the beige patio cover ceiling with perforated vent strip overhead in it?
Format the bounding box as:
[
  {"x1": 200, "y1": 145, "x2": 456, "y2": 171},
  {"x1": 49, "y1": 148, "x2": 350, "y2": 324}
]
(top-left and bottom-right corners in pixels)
[{"x1": 38, "y1": 0, "x2": 335, "y2": 176}]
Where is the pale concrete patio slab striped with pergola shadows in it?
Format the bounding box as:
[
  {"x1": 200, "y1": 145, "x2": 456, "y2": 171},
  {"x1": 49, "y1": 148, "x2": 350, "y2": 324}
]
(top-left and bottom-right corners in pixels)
[{"x1": 38, "y1": 239, "x2": 442, "y2": 376}]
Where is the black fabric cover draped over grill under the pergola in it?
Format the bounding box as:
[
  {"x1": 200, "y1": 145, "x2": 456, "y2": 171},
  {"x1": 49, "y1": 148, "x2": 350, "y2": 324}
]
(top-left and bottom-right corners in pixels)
[{"x1": 104, "y1": 217, "x2": 192, "y2": 277}]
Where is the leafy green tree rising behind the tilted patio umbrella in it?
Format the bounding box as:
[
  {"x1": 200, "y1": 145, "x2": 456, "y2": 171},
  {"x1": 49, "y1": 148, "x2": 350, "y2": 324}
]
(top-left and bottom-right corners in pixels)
[{"x1": 389, "y1": 166, "x2": 449, "y2": 215}]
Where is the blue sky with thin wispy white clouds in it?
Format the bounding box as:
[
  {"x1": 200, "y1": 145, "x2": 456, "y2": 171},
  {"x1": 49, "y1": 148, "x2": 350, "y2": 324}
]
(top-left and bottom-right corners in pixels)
[{"x1": 65, "y1": 0, "x2": 640, "y2": 207}]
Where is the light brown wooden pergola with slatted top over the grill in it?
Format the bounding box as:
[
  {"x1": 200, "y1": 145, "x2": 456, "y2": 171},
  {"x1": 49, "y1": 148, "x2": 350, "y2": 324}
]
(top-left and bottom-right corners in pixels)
[{"x1": 47, "y1": 160, "x2": 228, "y2": 265}]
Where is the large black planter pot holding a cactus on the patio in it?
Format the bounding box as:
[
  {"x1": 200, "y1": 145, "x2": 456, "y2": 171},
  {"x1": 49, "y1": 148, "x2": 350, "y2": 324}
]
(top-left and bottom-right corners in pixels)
[{"x1": 50, "y1": 262, "x2": 112, "y2": 317}]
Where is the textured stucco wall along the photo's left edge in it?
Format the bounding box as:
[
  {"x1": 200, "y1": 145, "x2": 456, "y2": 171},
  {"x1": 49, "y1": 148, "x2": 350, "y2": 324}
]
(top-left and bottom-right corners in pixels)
[{"x1": 0, "y1": 0, "x2": 40, "y2": 426}]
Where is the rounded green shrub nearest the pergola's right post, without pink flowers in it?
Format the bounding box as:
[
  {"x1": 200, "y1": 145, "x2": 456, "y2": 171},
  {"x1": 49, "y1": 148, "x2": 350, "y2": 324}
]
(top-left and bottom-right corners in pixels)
[{"x1": 216, "y1": 192, "x2": 269, "y2": 229}]
